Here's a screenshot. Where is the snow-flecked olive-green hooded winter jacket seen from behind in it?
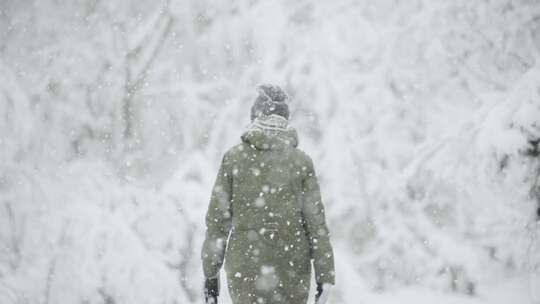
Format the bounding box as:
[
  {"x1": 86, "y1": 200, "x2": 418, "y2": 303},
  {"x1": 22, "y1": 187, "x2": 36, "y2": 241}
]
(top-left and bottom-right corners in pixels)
[{"x1": 202, "y1": 128, "x2": 334, "y2": 304}]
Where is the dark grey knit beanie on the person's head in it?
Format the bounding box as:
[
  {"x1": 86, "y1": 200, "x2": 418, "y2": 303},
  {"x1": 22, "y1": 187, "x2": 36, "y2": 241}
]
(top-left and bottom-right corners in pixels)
[{"x1": 251, "y1": 84, "x2": 289, "y2": 121}]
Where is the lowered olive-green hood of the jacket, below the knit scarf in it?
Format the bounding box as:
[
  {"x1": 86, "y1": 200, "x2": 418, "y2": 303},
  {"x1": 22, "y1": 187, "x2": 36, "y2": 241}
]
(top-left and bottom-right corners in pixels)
[{"x1": 241, "y1": 128, "x2": 298, "y2": 150}]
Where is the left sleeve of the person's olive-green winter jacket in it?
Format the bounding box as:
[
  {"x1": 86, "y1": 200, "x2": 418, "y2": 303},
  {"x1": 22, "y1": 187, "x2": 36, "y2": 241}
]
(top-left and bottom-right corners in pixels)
[{"x1": 201, "y1": 155, "x2": 232, "y2": 278}]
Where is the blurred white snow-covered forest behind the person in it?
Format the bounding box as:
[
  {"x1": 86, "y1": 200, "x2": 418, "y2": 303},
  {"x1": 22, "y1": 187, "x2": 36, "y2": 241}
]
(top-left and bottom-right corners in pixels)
[{"x1": 0, "y1": 0, "x2": 540, "y2": 304}]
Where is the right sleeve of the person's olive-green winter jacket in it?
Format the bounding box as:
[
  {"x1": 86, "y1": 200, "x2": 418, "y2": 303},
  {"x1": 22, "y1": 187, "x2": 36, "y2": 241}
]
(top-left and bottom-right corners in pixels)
[{"x1": 302, "y1": 158, "x2": 335, "y2": 284}]
